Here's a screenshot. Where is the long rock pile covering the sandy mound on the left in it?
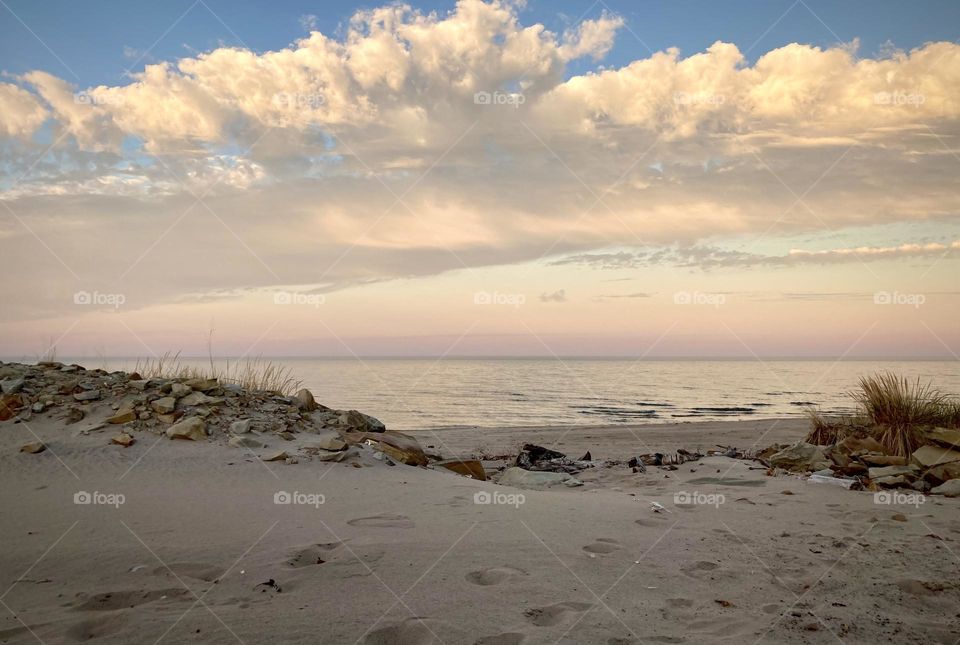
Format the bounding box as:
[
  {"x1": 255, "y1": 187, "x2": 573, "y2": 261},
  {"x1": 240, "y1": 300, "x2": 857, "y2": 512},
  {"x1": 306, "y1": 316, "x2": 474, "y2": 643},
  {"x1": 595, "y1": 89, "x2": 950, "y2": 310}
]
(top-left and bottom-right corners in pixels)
[{"x1": 0, "y1": 362, "x2": 486, "y2": 480}]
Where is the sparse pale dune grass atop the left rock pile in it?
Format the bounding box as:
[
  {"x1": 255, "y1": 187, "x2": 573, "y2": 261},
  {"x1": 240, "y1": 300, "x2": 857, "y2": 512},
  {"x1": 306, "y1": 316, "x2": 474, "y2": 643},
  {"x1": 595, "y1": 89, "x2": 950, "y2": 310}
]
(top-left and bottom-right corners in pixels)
[{"x1": 134, "y1": 352, "x2": 302, "y2": 396}]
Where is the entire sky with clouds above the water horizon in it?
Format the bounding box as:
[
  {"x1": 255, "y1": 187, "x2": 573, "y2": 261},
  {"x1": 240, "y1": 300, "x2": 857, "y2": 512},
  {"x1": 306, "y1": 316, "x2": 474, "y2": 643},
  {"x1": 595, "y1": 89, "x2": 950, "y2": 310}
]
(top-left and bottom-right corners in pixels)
[{"x1": 0, "y1": 0, "x2": 960, "y2": 360}]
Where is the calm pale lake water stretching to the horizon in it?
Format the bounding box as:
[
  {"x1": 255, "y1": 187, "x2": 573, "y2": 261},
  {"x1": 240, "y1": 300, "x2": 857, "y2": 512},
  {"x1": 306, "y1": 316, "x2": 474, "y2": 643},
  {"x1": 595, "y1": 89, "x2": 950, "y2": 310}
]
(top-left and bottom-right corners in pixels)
[{"x1": 78, "y1": 358, "x2": 960, "y2": 430}]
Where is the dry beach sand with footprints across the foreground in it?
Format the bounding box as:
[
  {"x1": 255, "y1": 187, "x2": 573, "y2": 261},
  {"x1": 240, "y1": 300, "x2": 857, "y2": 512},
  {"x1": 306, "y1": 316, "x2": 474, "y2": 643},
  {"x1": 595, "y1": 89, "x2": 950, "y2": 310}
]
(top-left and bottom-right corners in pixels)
[{"x1": 0, "y1": 419, "x2": 960, "y2": 645}]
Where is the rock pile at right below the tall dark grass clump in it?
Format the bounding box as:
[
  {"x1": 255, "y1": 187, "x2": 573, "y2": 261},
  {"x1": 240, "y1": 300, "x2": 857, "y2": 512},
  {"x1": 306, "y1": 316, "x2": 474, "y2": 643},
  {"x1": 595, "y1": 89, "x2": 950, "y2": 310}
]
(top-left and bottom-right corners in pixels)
[{"x1": 757, "y1": 428, "x2": 960, "y2": 497}]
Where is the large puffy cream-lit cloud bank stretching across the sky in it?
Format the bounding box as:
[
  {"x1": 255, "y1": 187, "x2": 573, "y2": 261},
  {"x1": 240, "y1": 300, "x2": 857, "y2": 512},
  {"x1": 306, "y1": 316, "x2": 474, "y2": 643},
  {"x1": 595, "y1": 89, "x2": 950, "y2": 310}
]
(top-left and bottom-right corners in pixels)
[{"x1": 0, "y1": 0, "x2": 960, "y2": 328}]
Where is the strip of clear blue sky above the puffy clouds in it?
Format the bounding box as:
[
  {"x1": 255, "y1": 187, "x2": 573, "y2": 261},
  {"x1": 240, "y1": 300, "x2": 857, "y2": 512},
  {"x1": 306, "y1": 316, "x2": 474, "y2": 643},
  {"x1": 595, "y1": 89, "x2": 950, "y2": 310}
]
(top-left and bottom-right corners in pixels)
[{"x1": 0, "y1": 0, "x2": 960, "y2": 86}]
